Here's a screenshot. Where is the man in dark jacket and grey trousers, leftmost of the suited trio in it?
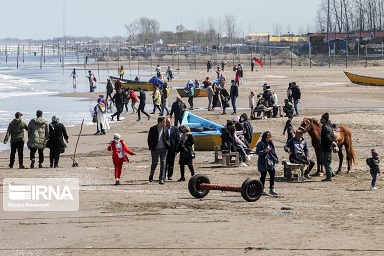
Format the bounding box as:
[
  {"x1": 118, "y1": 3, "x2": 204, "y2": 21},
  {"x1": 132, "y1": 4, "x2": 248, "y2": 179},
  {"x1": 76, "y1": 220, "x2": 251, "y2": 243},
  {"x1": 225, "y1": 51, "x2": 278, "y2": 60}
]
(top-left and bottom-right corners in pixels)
[{"x1": 148, "y1": 117, "x2": 169, "y2": 184}]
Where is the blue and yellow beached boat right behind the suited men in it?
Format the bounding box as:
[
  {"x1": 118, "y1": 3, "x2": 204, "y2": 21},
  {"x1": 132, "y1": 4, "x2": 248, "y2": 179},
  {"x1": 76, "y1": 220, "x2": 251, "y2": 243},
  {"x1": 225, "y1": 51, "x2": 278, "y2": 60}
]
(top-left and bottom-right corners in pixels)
[{"x1": 181, "y1": 111, "x2": 262, "y2": 151}]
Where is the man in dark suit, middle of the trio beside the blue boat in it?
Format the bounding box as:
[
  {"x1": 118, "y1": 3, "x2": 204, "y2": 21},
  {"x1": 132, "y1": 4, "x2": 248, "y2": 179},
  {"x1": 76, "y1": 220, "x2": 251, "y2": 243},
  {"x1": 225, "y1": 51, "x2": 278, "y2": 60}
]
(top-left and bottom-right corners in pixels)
[{"x1": 165, "y1": 118, "x2": 180, "y2": 180}]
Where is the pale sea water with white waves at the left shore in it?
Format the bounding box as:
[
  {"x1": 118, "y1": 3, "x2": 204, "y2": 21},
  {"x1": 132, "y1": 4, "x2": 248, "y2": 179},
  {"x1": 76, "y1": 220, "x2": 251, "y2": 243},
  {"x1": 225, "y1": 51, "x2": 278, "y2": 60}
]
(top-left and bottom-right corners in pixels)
[{"x1": 0, "y1": 55, "x2": 156, "y2": 151}]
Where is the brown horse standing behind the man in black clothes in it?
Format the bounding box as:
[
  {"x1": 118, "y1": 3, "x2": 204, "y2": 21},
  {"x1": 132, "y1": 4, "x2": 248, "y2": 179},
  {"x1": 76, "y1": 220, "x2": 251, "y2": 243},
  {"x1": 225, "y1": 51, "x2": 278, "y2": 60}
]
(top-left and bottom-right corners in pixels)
[{"x1": 301, "y1": 118, "x2": 356, "y2": 173}]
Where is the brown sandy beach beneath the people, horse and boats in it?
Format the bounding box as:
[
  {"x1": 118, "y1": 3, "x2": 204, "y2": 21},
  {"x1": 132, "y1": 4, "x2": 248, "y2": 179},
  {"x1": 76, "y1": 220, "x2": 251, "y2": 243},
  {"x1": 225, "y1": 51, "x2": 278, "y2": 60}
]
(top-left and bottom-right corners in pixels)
[{"x1": 0, "y1": 61, "x2": 384, "y2": 255}]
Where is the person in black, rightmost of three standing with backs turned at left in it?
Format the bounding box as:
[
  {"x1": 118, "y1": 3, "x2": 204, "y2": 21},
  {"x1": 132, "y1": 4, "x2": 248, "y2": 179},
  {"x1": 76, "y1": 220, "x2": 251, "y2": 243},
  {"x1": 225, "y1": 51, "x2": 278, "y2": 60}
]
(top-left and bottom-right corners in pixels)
[{"x1": 47, "y1": 116, "x2": 68, "y2": 168}]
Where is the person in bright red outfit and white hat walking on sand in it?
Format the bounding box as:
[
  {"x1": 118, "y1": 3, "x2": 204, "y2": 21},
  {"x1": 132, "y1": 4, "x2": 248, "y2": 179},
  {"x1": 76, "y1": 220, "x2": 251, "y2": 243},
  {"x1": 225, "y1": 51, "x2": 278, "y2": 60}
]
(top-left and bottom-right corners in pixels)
[{"x1": 108, "y1": 133, "x2": 136, "y2": 185}]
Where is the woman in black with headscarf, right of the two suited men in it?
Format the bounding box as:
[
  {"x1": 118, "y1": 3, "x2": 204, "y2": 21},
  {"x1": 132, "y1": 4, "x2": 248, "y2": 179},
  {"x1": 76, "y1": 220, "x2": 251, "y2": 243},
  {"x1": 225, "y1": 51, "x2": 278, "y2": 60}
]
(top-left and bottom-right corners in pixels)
[{"x1": 178, "y1": 125, "x2": 195, "y2": 182}]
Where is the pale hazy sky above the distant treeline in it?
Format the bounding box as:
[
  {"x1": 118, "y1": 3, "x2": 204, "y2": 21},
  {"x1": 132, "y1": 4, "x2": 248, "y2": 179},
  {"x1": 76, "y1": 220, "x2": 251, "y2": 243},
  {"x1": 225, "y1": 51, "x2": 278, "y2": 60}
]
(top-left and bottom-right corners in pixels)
[{"x1": 0, "y1": 0, "x2": 321, "y2": 40}]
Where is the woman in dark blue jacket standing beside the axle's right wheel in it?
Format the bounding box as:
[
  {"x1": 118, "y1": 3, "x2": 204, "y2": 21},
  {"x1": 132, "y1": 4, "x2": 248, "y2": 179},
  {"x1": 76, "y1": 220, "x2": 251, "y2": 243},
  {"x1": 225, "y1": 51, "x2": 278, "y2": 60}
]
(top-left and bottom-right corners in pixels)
[{"x1": 256, "y1": 131, "x2": 279, "y2": 196}]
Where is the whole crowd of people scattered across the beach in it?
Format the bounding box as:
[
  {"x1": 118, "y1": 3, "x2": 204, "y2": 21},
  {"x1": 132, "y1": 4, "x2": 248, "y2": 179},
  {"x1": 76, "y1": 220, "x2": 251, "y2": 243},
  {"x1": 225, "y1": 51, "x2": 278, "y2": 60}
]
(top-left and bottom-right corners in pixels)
[{"x1": 4, "y1": 61, "x2": 380, "y2": 195}]
